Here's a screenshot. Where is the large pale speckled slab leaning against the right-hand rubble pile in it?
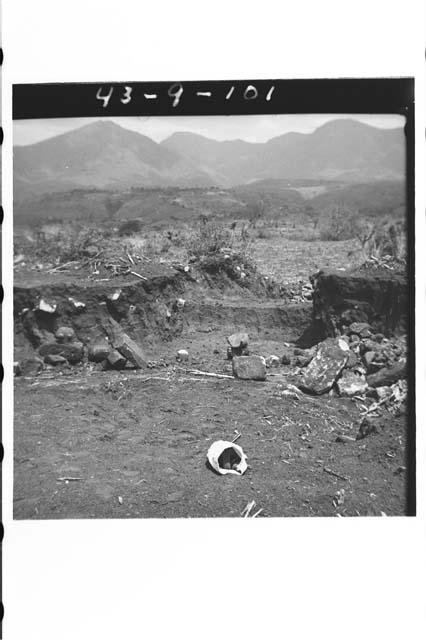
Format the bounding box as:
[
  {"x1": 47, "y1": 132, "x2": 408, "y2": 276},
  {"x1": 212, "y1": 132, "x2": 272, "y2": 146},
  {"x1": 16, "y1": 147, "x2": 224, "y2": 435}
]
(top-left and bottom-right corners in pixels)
[{"x1": 298, "y1": 338, "x2": 349, "y2": 395}]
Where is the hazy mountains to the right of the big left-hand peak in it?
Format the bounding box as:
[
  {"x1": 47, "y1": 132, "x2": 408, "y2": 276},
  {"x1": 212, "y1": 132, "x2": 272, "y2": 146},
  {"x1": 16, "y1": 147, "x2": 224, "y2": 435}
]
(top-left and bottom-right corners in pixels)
[{"x1": 162, "y1": 119, "x2": 405, "y2": 185}]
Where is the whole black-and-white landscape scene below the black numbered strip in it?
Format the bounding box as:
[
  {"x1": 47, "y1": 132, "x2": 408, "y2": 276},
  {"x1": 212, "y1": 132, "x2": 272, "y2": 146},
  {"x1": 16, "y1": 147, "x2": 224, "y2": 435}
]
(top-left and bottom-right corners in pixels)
[{"x1": 13, "y1": 100, "x2": 415, "y2": 519}]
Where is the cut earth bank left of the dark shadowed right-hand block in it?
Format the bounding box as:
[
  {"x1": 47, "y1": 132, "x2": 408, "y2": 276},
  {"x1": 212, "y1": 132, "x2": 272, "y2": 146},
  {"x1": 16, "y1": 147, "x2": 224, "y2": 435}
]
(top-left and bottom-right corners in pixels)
[{"x1": 14, "y1": 273, "x2": 312, "y2": 360}]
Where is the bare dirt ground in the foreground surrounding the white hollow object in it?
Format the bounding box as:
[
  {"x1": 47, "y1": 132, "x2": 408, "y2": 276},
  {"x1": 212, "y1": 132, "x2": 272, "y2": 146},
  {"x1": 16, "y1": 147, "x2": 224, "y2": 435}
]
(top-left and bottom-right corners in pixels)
[{"x1": 14, "y1": 331, "x2": 406, "y2": 519}]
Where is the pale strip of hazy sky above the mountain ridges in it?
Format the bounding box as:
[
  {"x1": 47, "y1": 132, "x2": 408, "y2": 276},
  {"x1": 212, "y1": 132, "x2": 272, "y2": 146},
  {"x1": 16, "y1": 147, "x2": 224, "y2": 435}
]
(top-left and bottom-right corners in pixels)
[{"x1": 13, "y1": 114, "x2": 405, "y2": 145}]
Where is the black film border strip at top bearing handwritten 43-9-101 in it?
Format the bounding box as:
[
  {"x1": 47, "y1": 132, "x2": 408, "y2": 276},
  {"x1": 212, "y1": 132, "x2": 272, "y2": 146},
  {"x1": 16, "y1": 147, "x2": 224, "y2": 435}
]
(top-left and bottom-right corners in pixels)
[{"x1": 13, "y1": 78, "x2": 414, "y2": 120}]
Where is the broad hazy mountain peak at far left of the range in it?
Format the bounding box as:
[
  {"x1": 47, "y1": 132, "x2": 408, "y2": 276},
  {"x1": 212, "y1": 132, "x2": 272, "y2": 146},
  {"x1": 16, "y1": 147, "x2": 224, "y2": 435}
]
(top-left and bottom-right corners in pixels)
[{"x1": 14, "y1": 121, "x2": 218, "y2": 201}]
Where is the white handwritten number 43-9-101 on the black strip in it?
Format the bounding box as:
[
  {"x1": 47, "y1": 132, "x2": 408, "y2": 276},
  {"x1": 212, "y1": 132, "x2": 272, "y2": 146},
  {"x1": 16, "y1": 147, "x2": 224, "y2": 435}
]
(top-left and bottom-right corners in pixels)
[{"x1": 96, "y1": 83, "x2": 275, "y2": 108}]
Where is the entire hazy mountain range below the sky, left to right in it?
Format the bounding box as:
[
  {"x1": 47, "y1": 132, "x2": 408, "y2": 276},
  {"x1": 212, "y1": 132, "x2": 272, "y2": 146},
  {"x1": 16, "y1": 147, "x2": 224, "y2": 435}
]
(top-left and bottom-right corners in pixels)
[{"x1": 14, "y1": 119, "x2": 405, "y2": 202}]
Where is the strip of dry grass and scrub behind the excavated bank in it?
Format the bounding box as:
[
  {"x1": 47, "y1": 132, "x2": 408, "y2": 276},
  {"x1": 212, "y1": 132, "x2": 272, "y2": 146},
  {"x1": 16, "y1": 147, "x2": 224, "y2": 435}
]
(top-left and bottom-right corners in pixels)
[{"x1": 14, "y1": 212, "x2": 406, "y2": 283}]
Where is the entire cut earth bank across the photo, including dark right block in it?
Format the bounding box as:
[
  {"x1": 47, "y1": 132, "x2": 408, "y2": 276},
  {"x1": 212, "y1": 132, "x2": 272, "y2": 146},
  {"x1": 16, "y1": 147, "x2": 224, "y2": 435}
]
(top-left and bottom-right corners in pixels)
[{"x1": 14, "y1": 268, "x2": 408, "y2": 360}]
